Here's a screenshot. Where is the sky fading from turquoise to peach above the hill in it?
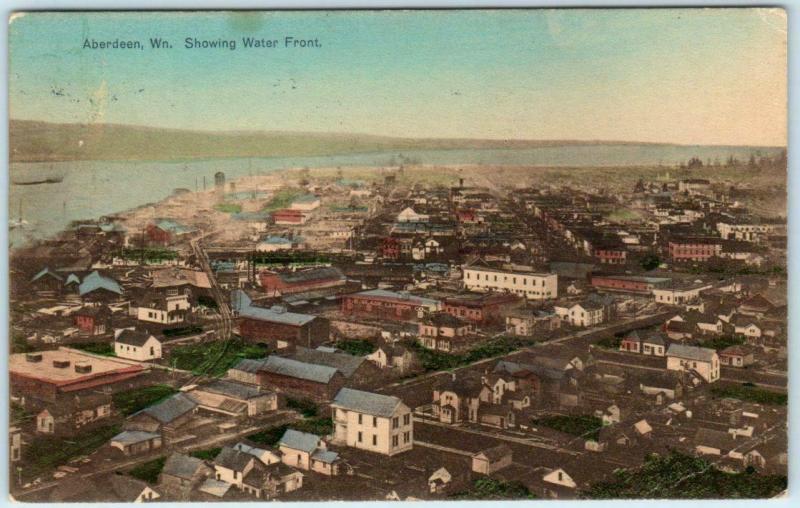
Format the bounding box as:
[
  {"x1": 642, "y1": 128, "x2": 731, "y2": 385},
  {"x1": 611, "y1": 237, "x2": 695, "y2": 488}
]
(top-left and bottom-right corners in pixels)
[{"x1": 9, "y1": 9, "x2": 786, "y2": 145}]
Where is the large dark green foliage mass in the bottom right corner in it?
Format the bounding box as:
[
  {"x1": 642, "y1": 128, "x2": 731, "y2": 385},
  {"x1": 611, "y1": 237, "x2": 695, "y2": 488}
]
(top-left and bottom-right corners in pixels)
[{"x1": 581, "y1": 452, "x2": 787, "y2": 499}]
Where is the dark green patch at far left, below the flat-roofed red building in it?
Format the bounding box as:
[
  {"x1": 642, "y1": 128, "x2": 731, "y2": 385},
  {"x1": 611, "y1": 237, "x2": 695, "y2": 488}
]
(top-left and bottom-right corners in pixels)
[{"x1": 22, "y1": 425, "x2": 120, "y2": 479}]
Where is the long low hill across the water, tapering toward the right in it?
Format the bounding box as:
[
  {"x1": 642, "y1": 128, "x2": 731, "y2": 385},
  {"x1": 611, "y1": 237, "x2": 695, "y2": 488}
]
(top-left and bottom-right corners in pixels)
[{"x1": 9, "y1": 120, "x2": 672, "y2": 162}]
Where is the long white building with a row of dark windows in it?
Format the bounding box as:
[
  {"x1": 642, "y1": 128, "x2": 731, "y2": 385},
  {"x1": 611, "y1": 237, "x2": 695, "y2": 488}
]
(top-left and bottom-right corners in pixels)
[{"x1": 463, "y1": 266, "x2": 558, "y2": 300}]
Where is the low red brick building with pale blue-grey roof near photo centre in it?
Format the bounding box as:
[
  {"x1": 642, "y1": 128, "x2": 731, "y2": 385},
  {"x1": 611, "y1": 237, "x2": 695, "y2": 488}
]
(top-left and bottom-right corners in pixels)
[{"x1": 342, "y1": 289, "x2": 441, "y2": 321}]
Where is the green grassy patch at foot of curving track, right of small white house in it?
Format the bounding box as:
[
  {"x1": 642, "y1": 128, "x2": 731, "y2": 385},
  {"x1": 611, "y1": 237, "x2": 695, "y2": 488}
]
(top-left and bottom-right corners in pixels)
[{"x1": 170, "y1": 339, "x2": 268, "y2": 377}]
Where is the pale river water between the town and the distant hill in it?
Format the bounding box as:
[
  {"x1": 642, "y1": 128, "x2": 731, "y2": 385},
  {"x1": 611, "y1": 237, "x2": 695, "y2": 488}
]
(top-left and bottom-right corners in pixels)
[{"x1": 9, "y1": 145, "x2": 778, "y2": 246}]
